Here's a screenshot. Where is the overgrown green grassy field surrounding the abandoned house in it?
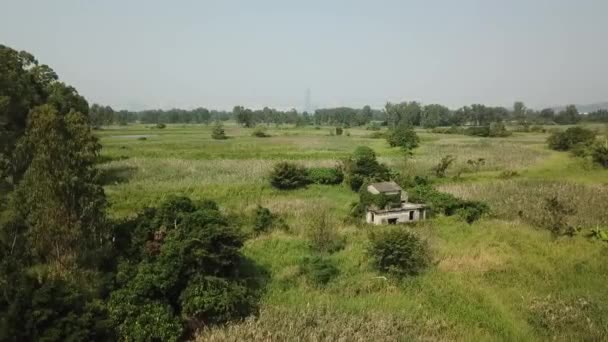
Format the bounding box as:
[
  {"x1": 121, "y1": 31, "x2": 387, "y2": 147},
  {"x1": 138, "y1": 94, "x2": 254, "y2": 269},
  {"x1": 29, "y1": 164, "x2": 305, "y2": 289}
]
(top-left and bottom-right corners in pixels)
[{"x1": 97, "y1": 124, "x2": 608, "y2": 341}]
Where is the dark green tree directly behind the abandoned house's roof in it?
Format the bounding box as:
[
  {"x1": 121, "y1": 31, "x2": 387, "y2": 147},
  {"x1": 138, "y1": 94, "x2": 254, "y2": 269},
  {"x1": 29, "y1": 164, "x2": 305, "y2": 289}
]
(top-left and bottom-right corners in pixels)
[{"x1": 342, "y1": 146, "x2": 390, "y2": 191}]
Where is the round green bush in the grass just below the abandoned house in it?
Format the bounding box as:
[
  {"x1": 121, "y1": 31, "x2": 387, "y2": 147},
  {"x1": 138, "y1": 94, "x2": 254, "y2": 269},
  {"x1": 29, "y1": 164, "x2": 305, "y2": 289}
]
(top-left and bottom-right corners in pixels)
[{"x1": 368, "y1": 227, "x2": 431, "y2": 277}]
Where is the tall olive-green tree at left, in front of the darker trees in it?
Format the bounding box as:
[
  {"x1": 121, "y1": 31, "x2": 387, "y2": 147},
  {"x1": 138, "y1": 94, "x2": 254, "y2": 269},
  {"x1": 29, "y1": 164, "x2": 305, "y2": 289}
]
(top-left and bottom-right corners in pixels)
[{"x1": 12, "y1": 105, "x2": 108, "y2": 273}]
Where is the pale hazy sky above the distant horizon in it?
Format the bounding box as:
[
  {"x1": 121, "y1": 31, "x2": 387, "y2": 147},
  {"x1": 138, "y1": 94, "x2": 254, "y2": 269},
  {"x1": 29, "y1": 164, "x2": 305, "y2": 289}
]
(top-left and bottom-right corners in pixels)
[{"x1": 0, "y1": 0, "x2": 608, "y2": 110}]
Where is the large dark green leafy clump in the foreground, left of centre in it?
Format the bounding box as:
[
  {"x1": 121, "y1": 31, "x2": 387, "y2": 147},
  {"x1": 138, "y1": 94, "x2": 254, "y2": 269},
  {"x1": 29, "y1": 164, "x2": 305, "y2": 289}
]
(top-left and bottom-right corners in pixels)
[{"x1": 108, "y1": 197, "x2": 258, "y2": 340}]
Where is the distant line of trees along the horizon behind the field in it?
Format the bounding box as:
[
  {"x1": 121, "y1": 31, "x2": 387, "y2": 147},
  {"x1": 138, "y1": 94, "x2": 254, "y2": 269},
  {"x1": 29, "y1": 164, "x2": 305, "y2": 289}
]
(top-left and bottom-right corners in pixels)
[{"x1": 87, "y1": 101, "x2": 608, "y2": 128}]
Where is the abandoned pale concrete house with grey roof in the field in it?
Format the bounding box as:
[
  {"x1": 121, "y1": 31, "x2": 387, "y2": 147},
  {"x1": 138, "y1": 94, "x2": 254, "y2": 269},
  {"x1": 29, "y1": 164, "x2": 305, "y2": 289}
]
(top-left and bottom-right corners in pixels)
[{"x1": 367, "y1": 182, "x2": 426, "y2": 225}]
